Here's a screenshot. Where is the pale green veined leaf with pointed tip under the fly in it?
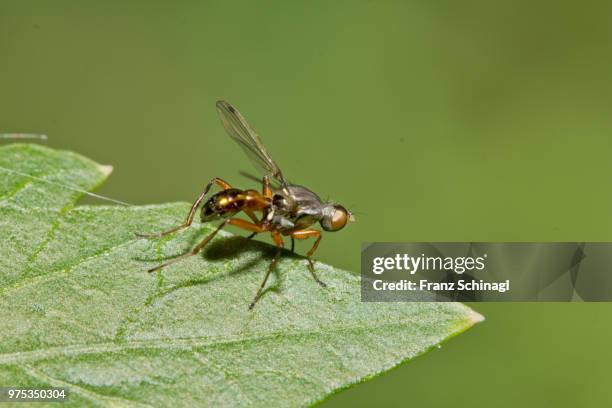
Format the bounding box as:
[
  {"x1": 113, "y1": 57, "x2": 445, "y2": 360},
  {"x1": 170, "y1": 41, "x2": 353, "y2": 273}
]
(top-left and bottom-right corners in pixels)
[{"x1": 0, "y1": 145, "x2": 481, "y2": 406}]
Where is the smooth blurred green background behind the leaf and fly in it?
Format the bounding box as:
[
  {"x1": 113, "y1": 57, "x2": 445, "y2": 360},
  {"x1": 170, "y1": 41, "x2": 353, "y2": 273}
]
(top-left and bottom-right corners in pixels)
[{"x1": 0, "y1": 0, "x2": 612, "y2": 407}]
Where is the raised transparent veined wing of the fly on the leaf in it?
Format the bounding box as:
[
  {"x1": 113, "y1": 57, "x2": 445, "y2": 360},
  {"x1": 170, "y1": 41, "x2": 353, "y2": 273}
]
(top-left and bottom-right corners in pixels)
[{"x1": 217, "y1": 101, "x2": 286, "y2": 186}]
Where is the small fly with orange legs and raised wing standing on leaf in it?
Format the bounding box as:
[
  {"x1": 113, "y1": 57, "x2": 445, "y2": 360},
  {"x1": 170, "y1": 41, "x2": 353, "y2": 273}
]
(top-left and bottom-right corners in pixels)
[{"x1": 136, "y1": 101, "x2": 354, "y2": 310}]
